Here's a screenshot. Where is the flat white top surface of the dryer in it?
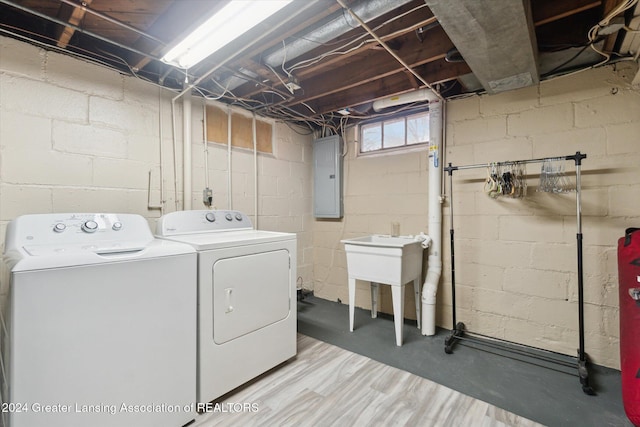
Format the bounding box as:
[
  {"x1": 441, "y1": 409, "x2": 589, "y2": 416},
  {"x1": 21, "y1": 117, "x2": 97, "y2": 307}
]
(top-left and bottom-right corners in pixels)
[{"x1": 162, "y1": 230, "x2": 296, "y2": 251}]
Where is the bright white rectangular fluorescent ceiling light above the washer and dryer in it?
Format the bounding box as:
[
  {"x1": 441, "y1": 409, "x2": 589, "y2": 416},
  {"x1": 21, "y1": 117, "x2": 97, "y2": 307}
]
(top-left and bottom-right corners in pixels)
[{"x1": 162, "y1": 0, "x2": 292, "y2": 69}]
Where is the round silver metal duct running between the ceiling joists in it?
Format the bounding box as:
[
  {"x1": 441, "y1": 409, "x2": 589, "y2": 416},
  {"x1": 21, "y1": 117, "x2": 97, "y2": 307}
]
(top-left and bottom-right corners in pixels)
[{"x1": 264, "y1": 0, "x2": 412, "y2": 67}]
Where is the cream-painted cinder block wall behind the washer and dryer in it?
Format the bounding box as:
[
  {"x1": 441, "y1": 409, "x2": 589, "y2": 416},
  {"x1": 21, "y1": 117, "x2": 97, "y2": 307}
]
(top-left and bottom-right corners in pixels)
[{"x1": 0, "y1": 37, "x2": 312, "y2": 287}]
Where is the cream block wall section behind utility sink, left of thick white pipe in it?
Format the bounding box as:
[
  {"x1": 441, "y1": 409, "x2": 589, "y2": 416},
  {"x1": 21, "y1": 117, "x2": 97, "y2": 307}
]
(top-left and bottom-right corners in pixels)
[{"x1": 313, "y1": 140, "x2": 428, "y2": 319}]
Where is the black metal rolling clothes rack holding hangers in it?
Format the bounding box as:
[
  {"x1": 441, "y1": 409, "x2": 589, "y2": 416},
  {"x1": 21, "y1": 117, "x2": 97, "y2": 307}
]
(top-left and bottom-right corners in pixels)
[{"x1": 444, "y1": 151, "x2": 595, "y2": 395}]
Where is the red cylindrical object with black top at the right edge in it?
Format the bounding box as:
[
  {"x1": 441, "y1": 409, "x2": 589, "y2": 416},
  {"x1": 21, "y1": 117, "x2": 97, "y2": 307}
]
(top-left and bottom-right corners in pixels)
[{"x1": 618, "y1": 228, "x2": 640, "y2": 427}]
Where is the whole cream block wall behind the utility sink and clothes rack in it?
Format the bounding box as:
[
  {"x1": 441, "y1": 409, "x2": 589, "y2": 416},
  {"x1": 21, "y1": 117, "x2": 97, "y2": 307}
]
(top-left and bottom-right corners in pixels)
[{"x1": 314, "y1": 63, "x2": 640, "y2": 368}]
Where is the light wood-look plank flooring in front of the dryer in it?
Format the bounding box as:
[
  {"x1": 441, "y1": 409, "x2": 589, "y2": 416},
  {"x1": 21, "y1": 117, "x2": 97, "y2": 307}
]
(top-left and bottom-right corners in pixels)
[{"x1": 192, "y1": 334, "x2": 540, "y2": 427}]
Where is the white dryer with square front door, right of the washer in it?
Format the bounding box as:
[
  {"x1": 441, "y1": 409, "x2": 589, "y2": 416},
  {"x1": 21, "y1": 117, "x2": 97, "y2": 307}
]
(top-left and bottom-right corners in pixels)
[{"x1": 156, "y1": 210, "x2": 296, "y2": 403}]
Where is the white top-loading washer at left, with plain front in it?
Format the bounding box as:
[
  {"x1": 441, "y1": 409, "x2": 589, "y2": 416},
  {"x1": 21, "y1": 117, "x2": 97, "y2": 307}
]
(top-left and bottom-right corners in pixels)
[{"x1": 2, "y1": 214, "x2": 197, "y2": 427}]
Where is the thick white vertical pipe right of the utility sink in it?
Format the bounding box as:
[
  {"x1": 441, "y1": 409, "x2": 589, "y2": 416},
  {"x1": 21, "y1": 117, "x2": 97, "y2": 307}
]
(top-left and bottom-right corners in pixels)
[{"x1": 422, "y1": 99, "x2": 444, "y2": 335}]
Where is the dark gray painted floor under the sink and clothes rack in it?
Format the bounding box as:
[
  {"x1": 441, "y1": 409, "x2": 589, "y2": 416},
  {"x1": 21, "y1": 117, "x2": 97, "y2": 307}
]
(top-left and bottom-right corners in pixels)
[{"x1": 298, "y1": 296, "x2": 632, "y2": 427}]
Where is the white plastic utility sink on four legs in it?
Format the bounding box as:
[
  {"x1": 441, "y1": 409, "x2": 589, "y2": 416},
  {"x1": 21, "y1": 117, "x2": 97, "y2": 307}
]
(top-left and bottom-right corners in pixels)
[{"x1": 340, "y1": 234, "x2": 423, "y2": 346}]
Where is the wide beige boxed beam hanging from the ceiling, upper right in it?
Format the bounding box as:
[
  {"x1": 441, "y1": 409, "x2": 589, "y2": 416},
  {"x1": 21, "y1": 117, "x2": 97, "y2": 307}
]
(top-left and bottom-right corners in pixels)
[{"x1": 425, "y1": 0, "x2": 540, "y2": 93}]
